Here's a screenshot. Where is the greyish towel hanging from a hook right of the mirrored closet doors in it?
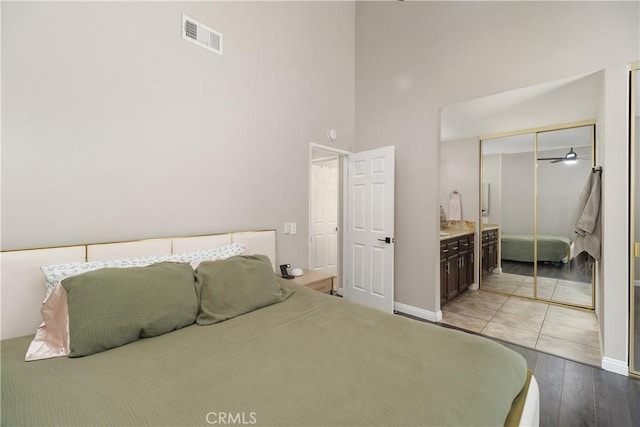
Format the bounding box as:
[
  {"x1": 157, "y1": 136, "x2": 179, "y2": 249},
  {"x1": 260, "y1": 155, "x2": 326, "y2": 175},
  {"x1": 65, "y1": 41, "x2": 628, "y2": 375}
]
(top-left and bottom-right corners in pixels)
[{"x1": 574, "y1": 172, "x2": 602, "y2": 260}]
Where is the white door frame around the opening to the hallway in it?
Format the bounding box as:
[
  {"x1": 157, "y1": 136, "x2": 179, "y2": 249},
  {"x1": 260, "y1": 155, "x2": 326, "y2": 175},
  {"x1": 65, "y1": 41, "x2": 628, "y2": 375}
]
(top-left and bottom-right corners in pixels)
[{"x1": 307, "y1": 142, "x2": 351, "y2": 293}]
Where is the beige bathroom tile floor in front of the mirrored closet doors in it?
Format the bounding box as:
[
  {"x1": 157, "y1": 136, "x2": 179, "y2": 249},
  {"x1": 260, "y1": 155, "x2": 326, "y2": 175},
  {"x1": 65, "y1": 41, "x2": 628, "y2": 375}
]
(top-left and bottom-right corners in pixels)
[{"x1": 440, "y1": 286, "x2": 601, "y2": 367}]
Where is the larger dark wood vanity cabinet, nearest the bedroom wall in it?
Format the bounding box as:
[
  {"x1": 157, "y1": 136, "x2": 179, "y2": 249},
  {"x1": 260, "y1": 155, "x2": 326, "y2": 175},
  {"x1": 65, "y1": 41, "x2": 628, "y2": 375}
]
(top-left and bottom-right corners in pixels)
[{"x1": 440, "y1": 234, "x2": 474, "y2": 305}]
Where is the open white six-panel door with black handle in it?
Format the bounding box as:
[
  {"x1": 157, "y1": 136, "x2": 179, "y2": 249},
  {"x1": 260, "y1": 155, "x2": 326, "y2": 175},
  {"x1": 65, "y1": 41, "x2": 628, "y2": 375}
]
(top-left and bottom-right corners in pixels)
[{"x1": 345, "y1": 146, "x2": 395, "y2": 313}]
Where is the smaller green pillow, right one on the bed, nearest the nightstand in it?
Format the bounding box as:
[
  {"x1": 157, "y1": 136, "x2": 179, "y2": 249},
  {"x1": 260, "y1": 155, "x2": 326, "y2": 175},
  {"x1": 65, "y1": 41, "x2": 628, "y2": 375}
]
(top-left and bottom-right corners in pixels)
[{"x1": 196, "y1": 255, "x2": 293, "y2": 325}]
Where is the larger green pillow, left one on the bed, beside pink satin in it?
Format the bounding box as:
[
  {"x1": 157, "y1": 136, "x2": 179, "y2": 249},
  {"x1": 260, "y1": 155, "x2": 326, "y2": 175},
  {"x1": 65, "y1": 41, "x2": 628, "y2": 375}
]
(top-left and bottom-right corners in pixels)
[{"x1": 62, "y1": 262, "x2": 198, "y2": 357}]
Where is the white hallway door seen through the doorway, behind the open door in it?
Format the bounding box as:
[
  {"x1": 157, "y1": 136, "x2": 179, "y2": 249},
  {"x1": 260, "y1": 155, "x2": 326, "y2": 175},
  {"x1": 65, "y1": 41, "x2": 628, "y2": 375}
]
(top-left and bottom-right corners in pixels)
[{"x1": 310, "y1": 157, "x2": 338, "y2": 276}]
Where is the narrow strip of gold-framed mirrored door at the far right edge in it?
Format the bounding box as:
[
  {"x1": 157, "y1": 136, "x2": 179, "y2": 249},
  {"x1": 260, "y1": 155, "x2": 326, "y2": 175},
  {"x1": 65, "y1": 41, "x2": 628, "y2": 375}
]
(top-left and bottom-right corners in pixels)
[{"x1": 629, "y1": 63, "x2": 640, "y2": 376}]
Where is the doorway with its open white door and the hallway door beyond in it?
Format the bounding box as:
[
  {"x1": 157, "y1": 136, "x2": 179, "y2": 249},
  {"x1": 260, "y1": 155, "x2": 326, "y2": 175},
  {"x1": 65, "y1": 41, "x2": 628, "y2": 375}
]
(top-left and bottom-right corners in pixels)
[{"x1": 309, "y1": 143, "x2": 395, "y2": 312}]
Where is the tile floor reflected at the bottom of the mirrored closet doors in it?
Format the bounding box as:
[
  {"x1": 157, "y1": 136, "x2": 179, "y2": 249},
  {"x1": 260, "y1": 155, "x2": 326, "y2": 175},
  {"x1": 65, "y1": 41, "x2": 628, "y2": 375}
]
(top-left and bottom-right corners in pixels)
[{"x1": 482, "y1": 273, "x2": 592, "y2": 307}]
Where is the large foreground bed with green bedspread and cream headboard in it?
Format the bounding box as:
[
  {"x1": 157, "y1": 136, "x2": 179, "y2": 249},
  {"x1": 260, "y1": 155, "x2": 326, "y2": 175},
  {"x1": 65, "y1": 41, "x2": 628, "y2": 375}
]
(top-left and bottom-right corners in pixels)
[{"x1": 1, "y1": 231, "x2": 539, "y2": 425}]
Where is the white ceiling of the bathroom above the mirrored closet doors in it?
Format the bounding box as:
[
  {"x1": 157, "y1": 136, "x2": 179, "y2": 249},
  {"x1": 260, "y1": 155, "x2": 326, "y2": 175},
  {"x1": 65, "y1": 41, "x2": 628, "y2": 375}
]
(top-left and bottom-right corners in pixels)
[{"x1": 440, "y1": 71, "x2": 603, "y2": 142}]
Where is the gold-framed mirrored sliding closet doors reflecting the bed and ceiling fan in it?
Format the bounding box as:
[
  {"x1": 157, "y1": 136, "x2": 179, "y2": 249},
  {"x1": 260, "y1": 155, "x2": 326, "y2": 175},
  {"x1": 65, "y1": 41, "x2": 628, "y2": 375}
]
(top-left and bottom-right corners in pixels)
[{"x1": 481, "y1": 125, "x2": 594, "y2": 308}]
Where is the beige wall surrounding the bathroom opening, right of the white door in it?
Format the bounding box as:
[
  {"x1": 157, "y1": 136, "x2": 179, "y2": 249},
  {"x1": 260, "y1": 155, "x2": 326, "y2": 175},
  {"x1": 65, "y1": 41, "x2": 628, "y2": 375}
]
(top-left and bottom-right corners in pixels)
[{"x1": 356, "y1": 2, "x2": 640, "y2": 368}]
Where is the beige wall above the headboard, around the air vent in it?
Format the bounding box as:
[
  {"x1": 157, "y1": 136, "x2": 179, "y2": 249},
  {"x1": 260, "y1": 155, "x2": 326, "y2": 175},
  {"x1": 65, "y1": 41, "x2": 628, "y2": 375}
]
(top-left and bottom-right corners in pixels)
[{"x1": 2, "y1": 1, "x2": 355, "y2": 274}]
